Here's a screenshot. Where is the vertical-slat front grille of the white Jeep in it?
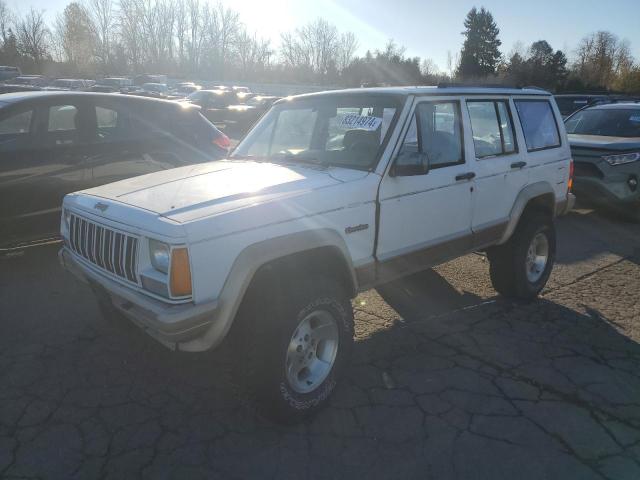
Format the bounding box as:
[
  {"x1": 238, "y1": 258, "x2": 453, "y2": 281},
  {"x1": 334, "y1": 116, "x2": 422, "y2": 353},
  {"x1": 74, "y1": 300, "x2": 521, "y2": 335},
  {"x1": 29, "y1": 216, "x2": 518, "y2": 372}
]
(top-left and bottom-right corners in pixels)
[{"x1": 69, "y1": 214, "x2": 138, "y2": 284}]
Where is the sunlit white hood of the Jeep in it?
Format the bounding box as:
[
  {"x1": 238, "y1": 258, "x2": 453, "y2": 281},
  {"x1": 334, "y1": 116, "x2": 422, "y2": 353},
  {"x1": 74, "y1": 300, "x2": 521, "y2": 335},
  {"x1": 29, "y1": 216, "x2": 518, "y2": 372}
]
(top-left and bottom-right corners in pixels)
[{"x1": 82, "y1": 160, "x2": 367, "y2": 223}]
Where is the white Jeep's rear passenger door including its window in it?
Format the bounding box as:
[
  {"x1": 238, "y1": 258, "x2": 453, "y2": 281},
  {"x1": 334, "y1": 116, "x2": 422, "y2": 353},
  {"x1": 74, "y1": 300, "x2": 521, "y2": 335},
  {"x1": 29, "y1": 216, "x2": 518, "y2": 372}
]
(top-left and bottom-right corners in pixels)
[{"x1": 466, "y1": 97, "x2": 529, "y2": 247}]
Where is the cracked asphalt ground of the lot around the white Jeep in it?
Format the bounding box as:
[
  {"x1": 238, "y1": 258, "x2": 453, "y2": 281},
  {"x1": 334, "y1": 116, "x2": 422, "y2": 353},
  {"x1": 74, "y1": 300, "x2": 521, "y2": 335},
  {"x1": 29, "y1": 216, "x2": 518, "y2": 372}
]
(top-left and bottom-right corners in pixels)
[{"x1": 0, "y1": 210, "x2": 640, "y2": 480}]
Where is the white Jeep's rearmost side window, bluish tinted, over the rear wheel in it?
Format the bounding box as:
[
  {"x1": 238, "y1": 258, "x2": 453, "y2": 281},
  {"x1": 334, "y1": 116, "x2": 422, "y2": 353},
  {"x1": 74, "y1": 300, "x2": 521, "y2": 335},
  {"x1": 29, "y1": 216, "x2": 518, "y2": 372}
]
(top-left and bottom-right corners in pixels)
[{"x1": 515, "y1": 100, "x2": 560, "y2": 152}]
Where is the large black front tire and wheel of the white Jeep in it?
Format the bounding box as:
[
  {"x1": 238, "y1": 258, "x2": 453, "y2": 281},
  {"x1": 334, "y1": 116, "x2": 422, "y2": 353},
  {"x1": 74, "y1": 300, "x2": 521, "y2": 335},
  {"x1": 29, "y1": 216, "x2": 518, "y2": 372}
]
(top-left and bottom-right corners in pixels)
[{"x1": 230, "y1": 270, "x2": 354, "y2": 424}]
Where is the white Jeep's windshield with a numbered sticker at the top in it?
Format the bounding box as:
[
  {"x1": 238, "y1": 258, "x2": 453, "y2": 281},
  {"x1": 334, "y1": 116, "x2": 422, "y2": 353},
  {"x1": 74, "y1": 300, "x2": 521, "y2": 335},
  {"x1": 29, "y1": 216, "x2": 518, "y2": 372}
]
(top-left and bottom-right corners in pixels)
[{"x1": 232, "y1": 95, "x2": 401, "y2": 170}]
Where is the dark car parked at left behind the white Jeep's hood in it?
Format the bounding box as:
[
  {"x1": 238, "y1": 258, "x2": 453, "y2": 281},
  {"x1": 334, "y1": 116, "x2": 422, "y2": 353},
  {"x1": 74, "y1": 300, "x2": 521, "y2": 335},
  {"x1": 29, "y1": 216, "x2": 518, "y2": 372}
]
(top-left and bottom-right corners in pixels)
[{"x1": 0, "y1": 91, "x2": 229, "y2": 250}]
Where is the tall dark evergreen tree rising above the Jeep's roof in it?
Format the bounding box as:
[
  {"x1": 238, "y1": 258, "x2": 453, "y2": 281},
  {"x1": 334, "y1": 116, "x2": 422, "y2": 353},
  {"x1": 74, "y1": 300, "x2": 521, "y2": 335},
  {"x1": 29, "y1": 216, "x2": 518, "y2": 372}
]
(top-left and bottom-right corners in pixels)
[{"x1": 458, "y1": 7, "x2": 501, "y2": 79}]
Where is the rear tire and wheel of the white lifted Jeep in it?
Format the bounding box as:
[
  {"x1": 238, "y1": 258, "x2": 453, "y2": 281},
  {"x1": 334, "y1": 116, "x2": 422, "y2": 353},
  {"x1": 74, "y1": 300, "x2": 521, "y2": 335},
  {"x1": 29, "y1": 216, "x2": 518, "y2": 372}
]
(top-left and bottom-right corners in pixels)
[{"x1": 487, "y1": 211, "x2": 556, "y2": 301}]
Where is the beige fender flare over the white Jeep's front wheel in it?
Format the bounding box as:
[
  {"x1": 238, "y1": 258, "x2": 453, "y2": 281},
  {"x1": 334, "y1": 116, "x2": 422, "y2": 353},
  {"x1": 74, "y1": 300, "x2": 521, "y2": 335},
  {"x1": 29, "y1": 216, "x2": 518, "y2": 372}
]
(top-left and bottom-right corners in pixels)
[{"x1": 178, "y1": 228, "x2": 358, "y2": 351}]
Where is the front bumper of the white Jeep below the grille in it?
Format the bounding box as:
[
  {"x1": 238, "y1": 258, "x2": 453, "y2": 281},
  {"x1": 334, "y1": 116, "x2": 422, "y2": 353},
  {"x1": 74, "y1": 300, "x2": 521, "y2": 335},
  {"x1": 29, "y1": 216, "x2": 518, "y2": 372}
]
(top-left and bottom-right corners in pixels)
[{"x1": 58, "y1": 248, "x2": 218, "y2": 350}]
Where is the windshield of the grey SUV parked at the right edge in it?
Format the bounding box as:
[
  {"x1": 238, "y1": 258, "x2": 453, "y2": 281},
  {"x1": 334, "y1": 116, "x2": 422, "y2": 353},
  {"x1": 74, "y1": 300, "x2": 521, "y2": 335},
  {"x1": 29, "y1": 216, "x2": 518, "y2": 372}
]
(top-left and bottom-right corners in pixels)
[{"x1": 566, "y1": 108, "x2": 640, "y2": 137}]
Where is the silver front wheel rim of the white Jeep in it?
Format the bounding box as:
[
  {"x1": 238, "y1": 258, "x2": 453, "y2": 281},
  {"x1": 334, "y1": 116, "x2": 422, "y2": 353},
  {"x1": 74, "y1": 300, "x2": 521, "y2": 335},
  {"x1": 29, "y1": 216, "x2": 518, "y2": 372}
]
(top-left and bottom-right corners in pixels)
[{"x1": 285, "y1": 310, "x2": 339, "y2": 393}]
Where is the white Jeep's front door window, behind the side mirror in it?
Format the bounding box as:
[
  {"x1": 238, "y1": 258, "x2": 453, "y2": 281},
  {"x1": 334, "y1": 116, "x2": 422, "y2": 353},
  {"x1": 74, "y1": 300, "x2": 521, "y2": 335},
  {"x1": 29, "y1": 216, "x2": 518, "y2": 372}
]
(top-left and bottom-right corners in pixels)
[{"x1": 396, "y1": 102, "x2": 464, "y2": 173}]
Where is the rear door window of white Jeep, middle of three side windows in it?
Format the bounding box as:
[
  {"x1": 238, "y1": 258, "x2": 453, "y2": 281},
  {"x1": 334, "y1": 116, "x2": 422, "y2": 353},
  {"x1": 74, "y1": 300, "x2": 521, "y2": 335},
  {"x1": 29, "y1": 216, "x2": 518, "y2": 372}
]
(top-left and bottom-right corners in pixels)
[{"x1": 467, "y1": 100, "x2": 516, "y2": 158}]
